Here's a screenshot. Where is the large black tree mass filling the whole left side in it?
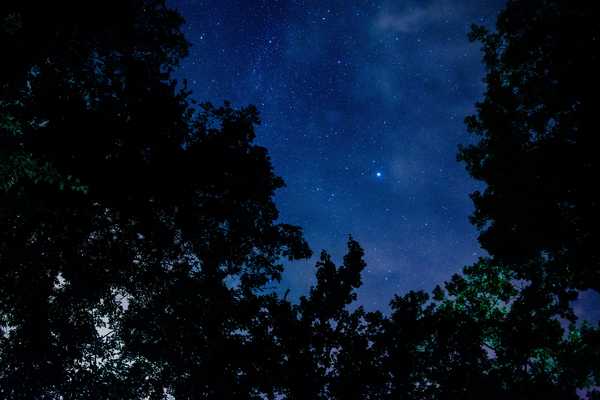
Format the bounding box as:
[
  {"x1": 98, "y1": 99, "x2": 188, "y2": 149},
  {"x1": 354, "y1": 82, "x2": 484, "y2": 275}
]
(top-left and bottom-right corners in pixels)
[{"x1": 0, "y1": 0, "x2": 310, "y2": 399}]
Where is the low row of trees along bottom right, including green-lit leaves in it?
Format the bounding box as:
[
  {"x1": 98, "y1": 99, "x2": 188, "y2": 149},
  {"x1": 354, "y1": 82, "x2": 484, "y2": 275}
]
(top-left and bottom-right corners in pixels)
[{"x1": 264, "y1": 255, "x2": 600, "y2": 400}]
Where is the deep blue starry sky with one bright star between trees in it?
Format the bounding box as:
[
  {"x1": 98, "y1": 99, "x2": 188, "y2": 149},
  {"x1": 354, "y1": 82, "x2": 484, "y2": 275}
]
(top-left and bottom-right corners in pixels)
[{"x1": 169, "y1": 0, "x2": 600, "y2": 310}]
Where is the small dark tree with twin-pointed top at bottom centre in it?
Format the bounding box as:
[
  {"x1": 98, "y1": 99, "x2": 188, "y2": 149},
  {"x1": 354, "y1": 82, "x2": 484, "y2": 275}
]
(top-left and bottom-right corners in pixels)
[{"x1": 270, "y1": 238, "x2": 385, "y2": 399}]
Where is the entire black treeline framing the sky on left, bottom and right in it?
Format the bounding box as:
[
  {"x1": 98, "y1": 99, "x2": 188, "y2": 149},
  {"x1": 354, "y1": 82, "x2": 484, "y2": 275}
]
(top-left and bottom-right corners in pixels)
[{"x1": 0, "y1": 0, "x2": 600, "y2": 400}]
